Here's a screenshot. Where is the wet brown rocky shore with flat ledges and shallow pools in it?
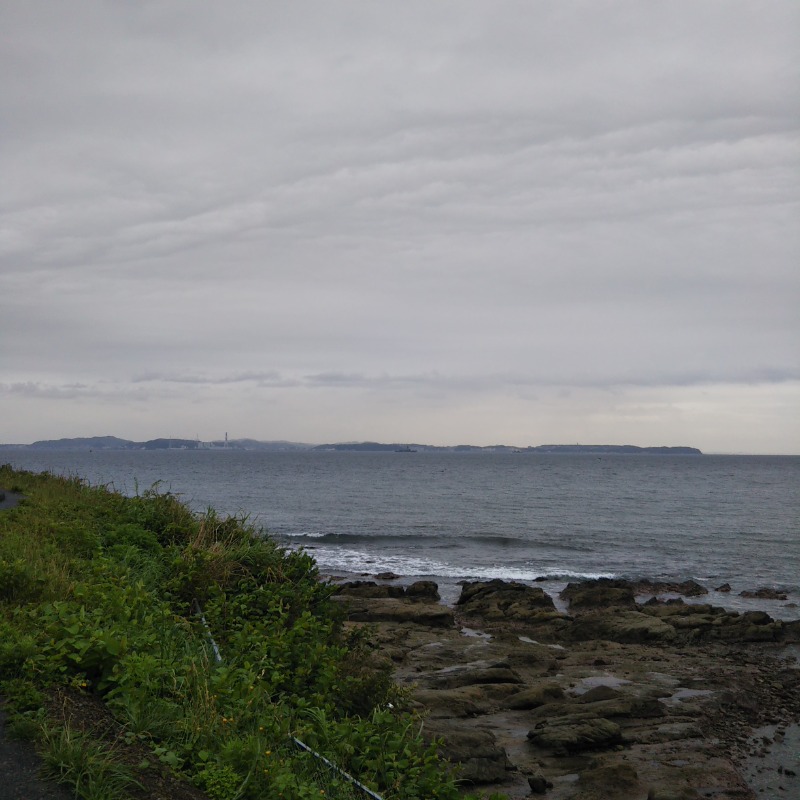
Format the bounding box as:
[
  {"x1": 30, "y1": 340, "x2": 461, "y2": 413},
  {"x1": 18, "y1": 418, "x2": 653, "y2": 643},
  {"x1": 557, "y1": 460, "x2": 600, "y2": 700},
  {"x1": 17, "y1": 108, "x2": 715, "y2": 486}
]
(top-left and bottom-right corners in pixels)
[{"x1": 338, "y1": 576, "x2": 800, "y2": 800}]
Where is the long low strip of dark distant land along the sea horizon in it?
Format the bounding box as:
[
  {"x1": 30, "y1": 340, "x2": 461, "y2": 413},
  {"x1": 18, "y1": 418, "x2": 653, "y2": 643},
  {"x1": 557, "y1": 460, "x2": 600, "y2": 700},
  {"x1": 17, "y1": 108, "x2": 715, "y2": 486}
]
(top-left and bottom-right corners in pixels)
[{"x1": 0, "y1": 436, "x2": 702, "y2": 456}]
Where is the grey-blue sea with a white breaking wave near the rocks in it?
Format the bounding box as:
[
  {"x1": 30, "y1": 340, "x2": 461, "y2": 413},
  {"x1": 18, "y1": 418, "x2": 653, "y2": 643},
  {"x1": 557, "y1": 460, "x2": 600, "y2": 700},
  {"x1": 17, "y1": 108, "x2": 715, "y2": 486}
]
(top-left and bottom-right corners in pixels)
[{"x1": 0, "y1": 449, "x2": 800, "y2": 619}]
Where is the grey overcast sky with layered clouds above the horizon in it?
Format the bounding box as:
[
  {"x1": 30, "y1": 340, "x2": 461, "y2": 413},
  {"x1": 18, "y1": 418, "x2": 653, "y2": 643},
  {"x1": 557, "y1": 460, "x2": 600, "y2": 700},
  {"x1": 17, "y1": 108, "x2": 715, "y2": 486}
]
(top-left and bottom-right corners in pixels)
[{"x1": 0, "y1": 0, "x2": 800, "y2": 453}]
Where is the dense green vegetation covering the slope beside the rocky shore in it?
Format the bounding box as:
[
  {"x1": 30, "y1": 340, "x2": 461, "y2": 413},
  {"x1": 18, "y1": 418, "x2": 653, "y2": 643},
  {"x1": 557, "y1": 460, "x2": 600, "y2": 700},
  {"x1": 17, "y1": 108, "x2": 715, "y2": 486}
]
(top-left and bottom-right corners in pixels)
[{"x1": 0, "y1": 465, "x2": 494, "y2": 800}]
